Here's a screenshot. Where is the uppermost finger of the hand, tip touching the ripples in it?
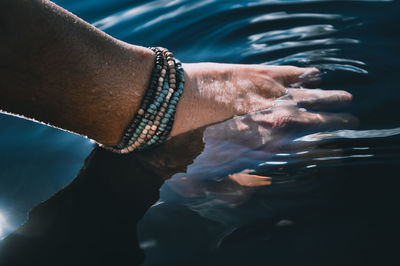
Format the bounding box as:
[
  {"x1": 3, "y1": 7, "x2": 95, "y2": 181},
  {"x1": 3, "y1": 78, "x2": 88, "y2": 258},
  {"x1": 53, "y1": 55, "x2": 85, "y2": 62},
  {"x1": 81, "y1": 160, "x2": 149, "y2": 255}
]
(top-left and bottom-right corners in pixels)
[{"x1": 269, "y1": 66, "x2": 320, "y2": 87}]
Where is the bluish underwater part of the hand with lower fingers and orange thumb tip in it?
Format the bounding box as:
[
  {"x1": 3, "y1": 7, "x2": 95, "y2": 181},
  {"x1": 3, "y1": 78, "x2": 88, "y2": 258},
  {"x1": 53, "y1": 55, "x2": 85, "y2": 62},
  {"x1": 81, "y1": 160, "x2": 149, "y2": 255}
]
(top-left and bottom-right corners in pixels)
[{"x1": 167, "y1": 84, "x2": 357, "y2": 191}]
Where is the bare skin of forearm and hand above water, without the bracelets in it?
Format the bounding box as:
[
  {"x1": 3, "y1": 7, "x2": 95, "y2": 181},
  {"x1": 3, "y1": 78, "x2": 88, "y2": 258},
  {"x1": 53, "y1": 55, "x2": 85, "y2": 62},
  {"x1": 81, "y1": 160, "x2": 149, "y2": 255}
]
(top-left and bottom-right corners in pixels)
[{"x1": 0, "y1": 0, "x2": 351, "y2": 148}]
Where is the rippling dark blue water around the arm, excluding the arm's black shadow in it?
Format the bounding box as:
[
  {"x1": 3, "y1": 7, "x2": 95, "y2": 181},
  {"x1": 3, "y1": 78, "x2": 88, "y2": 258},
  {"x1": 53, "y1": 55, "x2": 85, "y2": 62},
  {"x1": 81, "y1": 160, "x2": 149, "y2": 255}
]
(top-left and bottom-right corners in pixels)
[{"x1": 0, "y1": 0, "x2": 400, "y2": 265}]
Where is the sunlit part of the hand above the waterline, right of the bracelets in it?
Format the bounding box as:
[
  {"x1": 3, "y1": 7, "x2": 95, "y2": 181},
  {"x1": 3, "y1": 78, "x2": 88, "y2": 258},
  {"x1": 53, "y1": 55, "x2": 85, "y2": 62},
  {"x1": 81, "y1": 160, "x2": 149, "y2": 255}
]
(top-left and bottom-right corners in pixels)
[{"x1": 172, "y1": 63, "x2": 319, "y2": 136}]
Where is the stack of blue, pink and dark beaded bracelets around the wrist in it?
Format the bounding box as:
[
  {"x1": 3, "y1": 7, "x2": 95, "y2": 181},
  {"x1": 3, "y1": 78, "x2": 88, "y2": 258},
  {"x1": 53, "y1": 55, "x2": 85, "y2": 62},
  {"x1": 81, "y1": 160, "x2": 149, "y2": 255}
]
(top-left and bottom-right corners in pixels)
[{"x1": 100, "y1": 47, "x2": 184, "y2": 153}]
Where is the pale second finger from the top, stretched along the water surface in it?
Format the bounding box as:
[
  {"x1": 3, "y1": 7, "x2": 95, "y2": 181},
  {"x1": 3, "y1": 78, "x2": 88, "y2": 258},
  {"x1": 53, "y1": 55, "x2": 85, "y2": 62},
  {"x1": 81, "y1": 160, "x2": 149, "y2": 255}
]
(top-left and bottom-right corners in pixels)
[{"x1": 286, "y1": 89, "x2": 353, "y2": 109}]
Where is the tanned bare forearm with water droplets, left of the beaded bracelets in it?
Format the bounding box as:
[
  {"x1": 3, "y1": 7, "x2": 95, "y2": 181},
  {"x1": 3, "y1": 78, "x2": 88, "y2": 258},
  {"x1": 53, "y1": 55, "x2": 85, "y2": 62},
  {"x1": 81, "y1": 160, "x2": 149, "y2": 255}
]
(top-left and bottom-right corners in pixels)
[{"x1": 0, "y1": 0, "x2": 154, "y2": 144}]
